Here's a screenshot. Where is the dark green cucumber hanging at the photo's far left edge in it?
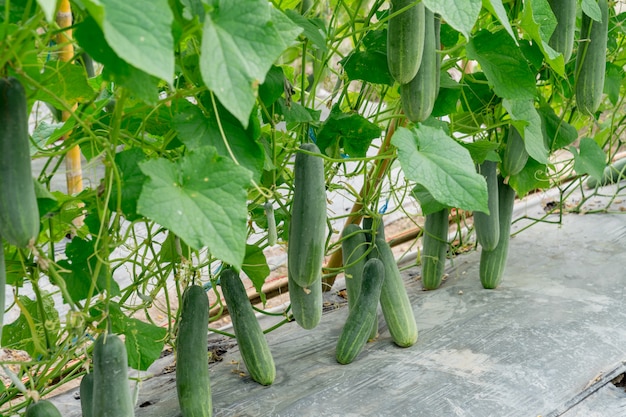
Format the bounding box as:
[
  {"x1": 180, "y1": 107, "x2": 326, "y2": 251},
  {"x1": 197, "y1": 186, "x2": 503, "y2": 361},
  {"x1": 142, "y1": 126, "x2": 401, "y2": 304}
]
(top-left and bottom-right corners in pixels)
[{"x1": 0, "y1": 77, "x2": 39, "y2": 248}]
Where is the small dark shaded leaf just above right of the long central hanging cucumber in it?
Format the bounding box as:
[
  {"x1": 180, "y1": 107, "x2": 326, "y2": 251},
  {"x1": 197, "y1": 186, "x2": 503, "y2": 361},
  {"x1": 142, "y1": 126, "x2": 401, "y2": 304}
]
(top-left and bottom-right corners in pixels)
[{"x1": 317, "y1": 107, "x2": 381, "y2": 157}]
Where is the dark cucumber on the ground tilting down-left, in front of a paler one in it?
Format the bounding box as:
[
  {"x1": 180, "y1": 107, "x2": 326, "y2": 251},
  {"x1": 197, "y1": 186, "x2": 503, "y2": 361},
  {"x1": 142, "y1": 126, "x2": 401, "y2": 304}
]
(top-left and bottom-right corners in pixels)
[{"x1": 335, "y1": 258, "x2": 385, "y2": 365}]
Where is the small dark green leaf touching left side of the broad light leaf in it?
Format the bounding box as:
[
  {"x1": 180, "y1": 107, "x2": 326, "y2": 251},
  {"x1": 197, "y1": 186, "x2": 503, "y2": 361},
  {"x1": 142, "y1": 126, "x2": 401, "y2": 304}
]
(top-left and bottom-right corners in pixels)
[{"x1": 109, "y1": 148, "x2": 146, "y2": 221}]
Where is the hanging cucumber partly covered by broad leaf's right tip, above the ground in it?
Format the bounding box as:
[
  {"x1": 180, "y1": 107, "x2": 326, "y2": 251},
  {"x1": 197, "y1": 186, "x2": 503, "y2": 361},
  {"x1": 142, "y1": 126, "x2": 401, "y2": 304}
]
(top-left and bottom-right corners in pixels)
[{"x1": 474, "y1": 161, "x2": 500, "y2": 250}]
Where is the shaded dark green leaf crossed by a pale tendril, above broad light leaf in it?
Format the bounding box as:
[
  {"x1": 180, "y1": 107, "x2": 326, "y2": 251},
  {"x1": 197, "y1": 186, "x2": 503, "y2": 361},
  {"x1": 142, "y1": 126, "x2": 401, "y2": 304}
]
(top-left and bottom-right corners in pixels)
[{"x1": 174, "y1": 100, "x2": 265, "y2": 181}]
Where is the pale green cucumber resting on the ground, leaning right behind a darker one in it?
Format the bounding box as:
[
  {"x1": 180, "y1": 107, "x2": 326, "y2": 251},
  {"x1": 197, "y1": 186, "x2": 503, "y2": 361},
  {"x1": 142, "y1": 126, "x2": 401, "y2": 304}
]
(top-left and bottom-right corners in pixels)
[{"x1": 375, "y1": 237, "x2": 417, "y2": 347}]
